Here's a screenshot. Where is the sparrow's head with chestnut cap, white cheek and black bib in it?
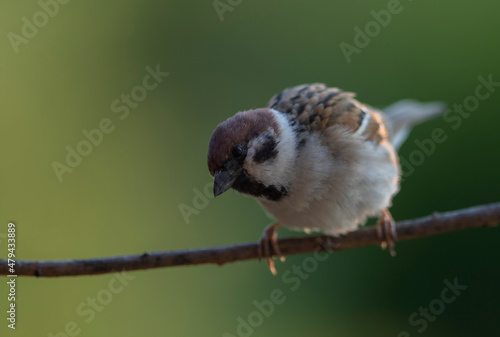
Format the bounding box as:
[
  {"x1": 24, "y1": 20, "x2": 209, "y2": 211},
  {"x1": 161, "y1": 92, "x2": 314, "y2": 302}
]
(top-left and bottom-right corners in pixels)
[{"x1": 207, "y1": 108, "x2": 296, "y2": 201}]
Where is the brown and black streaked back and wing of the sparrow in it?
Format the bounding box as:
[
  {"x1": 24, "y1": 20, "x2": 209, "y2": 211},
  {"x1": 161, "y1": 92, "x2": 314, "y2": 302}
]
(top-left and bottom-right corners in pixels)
[{"x1": 267, "y1": 83, "x2": 387, "y2": 144}]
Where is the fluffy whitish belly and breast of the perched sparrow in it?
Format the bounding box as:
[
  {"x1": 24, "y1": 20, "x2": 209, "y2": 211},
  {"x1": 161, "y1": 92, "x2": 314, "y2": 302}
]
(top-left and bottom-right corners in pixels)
[{"x1": 259, "y1": 128, "x2": 399, "y2": 235}]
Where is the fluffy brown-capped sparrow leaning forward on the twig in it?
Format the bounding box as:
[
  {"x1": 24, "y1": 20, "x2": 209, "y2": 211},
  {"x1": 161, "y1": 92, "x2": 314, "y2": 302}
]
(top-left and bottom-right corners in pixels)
[{"x1": 207, "y1": 83, "x2": 444, "y2": 274}]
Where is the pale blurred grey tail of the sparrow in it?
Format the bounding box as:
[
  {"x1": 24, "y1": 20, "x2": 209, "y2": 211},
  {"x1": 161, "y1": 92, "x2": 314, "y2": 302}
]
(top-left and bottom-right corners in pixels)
[{"x1": 383, "y1": 99, "x2": 446, "y2": 149}]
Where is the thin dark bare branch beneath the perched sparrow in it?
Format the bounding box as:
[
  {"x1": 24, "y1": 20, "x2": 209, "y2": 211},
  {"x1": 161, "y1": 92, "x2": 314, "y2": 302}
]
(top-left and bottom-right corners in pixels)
[{"x1": 0, "y1": 203, "x2": 500, "y2": 277}]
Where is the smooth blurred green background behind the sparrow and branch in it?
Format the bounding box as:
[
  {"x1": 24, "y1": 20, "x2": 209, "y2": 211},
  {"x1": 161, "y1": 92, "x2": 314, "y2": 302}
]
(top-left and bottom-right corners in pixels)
[{"x1": 0, "y1": 0, "x2": 500, "y2": 336}]
